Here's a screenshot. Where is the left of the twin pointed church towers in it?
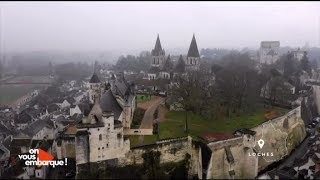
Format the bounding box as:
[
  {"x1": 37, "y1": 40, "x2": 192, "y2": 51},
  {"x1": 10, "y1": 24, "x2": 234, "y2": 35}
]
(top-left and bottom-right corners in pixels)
[{"x1": 151, "y1": 34, "x2": 165, "y2": 69}]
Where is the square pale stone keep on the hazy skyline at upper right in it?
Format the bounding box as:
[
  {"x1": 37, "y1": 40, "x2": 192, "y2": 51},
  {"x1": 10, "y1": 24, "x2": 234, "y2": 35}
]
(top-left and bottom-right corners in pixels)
[{"x1": 259, "y1": 41, "x2": 280, "y2": 64}]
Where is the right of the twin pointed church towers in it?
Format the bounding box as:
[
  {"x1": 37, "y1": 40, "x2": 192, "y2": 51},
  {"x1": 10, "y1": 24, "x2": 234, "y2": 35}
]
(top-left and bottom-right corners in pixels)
[{"x1": 185, "y1": 34, "x2": 200, "y2": 71}]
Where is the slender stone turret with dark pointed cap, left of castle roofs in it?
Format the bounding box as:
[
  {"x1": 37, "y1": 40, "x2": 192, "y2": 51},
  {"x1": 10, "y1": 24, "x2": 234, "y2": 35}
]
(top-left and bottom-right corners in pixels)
[{"x1": 89, "y1": 73, "x2": 101, "y2": 104}]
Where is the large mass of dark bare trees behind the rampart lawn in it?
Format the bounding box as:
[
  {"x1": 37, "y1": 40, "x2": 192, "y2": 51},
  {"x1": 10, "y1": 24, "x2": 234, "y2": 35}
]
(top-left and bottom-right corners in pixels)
[{"x1": 170, "y1": 52, "x2": 309, "y2": 129}]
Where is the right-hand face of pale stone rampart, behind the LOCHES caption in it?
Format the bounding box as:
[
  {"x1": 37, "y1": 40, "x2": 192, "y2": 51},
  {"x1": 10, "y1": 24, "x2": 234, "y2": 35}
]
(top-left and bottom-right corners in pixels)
[{"x1": 252, "y1": 106, "x2": 306, "y2": 171}]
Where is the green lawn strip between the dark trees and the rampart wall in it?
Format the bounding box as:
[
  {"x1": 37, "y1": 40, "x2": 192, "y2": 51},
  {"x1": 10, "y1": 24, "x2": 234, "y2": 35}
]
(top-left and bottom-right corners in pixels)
[{"x1": 160, "y1": 106, "x2": 289, "y2": 139}]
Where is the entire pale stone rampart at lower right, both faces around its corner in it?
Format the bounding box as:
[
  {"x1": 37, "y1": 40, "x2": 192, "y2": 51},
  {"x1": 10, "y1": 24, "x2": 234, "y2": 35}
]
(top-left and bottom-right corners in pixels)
[{"x1": 206, "y1": 106, "x2": 306, "y2": 179}]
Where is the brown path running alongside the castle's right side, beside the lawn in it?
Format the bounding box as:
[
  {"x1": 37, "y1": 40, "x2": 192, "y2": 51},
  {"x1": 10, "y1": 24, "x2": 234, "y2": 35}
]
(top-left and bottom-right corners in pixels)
[{"x1": 138, "y1": 97, "x2": 164, "y2": 144}]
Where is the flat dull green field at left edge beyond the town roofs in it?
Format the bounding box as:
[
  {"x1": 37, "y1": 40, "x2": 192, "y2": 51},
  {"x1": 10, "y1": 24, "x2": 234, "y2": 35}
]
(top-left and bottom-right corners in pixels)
[{"x1": 0, "y1": 84, "x2": 39, "y2": 104}]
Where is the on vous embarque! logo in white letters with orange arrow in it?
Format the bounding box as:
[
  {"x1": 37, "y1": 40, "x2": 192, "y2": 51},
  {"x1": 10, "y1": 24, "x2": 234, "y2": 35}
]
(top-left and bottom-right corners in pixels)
[{"x1": 18, "y1": 148, "x2": 68, "y2": 168}]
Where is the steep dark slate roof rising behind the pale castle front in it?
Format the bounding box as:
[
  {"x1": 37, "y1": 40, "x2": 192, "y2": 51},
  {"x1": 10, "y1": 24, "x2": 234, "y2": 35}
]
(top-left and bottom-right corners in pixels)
[{"x1": 100, "y1": 90, "x2": 122, "y2": 120}]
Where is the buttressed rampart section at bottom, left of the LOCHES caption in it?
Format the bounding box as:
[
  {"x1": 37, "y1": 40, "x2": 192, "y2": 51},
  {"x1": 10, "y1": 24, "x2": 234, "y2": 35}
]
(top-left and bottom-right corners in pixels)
[{"x1": 206, "y1": 137, "x2": 258, "y2": 179}]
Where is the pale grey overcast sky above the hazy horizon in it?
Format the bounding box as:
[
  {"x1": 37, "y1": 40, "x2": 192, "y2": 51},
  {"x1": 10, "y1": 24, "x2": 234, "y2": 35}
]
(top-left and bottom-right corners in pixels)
[{"x1": 0, "y1": 2, "x2": 320, "y2": 51}]
